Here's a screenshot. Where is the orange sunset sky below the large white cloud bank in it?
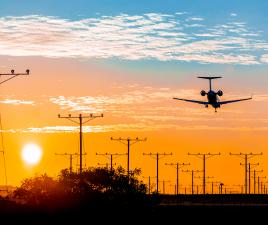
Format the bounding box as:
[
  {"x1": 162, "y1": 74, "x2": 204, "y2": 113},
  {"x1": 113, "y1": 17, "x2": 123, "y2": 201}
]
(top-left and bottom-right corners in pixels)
[{"x1": 0, "y1": 57, "x2": 268, "y2": 192}]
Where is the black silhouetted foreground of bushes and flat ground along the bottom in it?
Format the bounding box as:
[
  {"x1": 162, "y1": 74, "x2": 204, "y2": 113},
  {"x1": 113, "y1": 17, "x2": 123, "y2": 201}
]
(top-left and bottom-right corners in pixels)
[{"x1": 0, "y1": 167, "x2": 268, "y2": 224}]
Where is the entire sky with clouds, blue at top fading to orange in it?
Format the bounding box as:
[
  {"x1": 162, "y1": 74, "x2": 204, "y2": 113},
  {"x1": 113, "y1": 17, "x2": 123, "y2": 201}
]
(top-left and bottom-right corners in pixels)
[{"x1": 0, "y1": 0, "x2": 268, "y2": 192}]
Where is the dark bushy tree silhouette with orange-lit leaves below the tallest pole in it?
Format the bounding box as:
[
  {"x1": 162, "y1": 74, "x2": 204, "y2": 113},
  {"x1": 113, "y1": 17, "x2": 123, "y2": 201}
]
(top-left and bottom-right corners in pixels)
[{"x1": 13, "y1": 167, "x2": 148, "y2": 212}]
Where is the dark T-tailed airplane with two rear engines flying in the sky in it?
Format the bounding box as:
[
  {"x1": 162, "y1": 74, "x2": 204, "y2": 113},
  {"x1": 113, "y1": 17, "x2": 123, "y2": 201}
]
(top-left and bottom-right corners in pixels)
[{"x1": 173, "y1": 77, "x2": 252, "y2": 112}]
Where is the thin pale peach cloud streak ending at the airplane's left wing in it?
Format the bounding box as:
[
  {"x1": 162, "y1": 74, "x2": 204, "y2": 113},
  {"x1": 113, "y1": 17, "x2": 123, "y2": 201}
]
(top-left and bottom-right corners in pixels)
[{"x1": 49, "y1": 85, "x2": 199, "y2": 113}]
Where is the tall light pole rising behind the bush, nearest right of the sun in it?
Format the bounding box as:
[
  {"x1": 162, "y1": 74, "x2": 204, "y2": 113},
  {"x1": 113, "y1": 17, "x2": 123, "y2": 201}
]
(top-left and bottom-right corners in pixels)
[{"x1": 58, "y1": 114, "x2": 103, "y2": 173}]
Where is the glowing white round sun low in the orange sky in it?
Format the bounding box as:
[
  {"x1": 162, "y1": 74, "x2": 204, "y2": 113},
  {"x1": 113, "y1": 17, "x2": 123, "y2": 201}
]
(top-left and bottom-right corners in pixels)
[{"x1": 21, "y1": 144, "x2": 42, "y2": 165}]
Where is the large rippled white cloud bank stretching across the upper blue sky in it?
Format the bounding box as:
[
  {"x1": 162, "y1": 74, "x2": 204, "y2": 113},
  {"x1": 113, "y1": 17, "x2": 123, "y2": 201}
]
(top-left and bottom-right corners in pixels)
[{"x1": 0, "y1": 12, "x2": 268, "y2": 65}]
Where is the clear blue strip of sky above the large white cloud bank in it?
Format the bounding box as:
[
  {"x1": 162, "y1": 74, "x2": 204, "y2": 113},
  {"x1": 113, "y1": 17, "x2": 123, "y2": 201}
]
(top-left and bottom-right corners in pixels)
[{"x1": 0, "y1": 0, "x2": 268, "y2": 32}]
